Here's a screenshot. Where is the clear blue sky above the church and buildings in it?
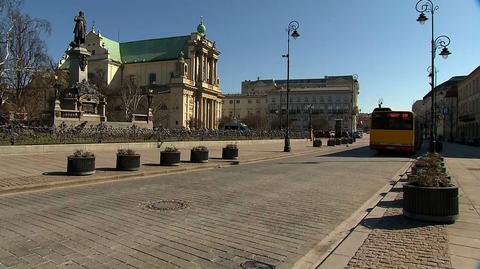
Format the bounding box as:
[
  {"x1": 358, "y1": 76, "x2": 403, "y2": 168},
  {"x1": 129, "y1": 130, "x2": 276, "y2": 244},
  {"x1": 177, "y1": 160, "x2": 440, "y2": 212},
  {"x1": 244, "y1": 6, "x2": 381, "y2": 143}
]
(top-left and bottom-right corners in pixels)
[{"x1": 24, "y1": 0, "x2": 480, "y2": 112}]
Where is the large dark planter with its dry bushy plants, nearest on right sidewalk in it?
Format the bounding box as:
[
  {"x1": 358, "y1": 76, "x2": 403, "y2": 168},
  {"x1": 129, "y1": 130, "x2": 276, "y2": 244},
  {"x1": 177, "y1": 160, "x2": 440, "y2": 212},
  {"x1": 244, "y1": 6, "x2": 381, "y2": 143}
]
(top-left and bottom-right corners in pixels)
[{"x1": 403, "y1": 153, "x2": 459, "y2": 223}]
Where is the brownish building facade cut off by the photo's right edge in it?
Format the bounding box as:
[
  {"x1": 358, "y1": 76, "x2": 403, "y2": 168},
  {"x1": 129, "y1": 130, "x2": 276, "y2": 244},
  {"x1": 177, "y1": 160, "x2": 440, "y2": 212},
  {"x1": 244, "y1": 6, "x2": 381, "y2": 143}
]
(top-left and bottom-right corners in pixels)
[{"x1": 458, "y1": 66, "x2": 480, "y2": 145}]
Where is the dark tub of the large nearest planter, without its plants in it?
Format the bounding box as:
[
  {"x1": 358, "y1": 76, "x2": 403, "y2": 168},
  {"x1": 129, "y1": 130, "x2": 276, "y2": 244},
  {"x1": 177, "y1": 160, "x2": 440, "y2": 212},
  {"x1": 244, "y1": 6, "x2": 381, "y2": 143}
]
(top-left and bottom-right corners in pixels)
[{"x1": 403, "y1": 184, "x2": 459, "y2": 223}]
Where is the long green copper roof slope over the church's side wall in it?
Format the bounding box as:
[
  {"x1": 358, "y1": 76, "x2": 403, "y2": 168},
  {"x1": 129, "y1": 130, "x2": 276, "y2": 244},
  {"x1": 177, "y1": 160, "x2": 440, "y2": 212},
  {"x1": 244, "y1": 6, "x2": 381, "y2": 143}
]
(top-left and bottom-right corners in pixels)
[{"x1": 120, "y1": 35, "x2": 190, "y2": 63}]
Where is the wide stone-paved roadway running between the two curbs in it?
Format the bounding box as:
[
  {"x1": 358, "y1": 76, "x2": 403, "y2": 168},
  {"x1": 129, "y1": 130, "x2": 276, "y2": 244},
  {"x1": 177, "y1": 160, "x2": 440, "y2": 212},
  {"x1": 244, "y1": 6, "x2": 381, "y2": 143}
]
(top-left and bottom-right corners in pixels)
[{"x1": 0, "y1": 144, "x2": 408, "y2": 268}]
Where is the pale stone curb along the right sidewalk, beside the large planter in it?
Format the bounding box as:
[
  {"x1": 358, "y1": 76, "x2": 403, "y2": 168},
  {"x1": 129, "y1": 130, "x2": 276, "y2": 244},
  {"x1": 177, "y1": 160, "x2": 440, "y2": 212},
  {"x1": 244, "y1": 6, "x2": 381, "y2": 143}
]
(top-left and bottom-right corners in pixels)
[{"x1": 292, "y1": 160, "x2": 412, "y2": 269}]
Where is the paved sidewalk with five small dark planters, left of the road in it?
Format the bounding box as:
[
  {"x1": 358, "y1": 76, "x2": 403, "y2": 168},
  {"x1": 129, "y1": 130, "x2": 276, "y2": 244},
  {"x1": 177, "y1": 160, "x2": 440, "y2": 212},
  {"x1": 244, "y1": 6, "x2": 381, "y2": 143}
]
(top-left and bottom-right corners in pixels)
[{"x1": 0, "y1": 139, "x2": 368, "y2": 194}]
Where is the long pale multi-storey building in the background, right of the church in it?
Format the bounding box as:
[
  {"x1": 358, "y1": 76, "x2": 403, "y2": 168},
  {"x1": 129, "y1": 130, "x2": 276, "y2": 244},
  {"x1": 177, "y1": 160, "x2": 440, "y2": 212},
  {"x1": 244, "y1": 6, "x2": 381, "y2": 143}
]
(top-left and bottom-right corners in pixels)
[{"x1": 223, "y1": 76, "x2": 359, "y2": 132}]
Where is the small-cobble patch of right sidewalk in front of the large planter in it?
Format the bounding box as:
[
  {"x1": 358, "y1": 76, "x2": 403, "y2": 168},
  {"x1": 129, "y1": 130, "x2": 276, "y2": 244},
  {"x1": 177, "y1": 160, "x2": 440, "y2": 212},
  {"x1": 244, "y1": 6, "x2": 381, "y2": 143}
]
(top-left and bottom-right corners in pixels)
[{"x1": 346, "y1": 193, "x2": 450, "y2": 269}]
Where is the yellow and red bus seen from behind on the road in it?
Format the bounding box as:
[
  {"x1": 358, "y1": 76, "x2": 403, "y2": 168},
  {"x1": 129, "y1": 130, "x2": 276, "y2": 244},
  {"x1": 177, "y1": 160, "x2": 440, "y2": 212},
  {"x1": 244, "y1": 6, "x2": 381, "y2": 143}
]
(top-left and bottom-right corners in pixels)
[{"x1": 370, "y1": 108, "x2": 421, "y2": 153}]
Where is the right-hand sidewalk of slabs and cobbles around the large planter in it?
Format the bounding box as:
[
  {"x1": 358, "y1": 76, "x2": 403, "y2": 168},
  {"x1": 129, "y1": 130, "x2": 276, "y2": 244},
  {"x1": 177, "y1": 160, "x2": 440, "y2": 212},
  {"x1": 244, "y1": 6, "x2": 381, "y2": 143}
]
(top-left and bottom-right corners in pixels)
[{"x1": 318, "y1": 143, "x2": 480, "y2": 269}]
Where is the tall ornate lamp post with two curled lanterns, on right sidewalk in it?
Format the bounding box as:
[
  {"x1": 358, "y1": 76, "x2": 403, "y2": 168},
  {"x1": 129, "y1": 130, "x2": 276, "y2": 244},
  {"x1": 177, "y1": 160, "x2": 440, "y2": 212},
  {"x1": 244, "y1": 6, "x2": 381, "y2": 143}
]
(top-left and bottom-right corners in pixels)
[{"x1": 415, "y1": 0, "x2": 451, "y2": 152}]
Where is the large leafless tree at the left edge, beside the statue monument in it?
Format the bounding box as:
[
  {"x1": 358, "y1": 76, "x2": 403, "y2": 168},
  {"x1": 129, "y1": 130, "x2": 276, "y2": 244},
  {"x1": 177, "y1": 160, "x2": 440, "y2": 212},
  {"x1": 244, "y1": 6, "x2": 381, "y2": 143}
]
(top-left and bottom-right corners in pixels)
[{"x1": 2, "y1": 0, "x2": 51, "y2": 110}]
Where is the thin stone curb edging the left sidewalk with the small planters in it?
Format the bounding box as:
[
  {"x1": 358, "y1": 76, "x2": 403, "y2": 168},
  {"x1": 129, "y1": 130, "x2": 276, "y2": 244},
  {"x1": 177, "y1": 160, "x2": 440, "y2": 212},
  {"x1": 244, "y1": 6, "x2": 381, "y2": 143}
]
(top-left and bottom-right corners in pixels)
[{"x1": 0, "y1": 141, "x2": 360, "y2": 196}]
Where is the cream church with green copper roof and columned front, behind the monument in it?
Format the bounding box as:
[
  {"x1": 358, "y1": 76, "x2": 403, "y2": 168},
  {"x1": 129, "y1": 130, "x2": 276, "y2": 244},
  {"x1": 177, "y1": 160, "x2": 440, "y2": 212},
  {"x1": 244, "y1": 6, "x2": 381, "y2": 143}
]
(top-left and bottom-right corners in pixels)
[{"x1": 61, "y1": 22, "x2": 223, "y2": 128}]
